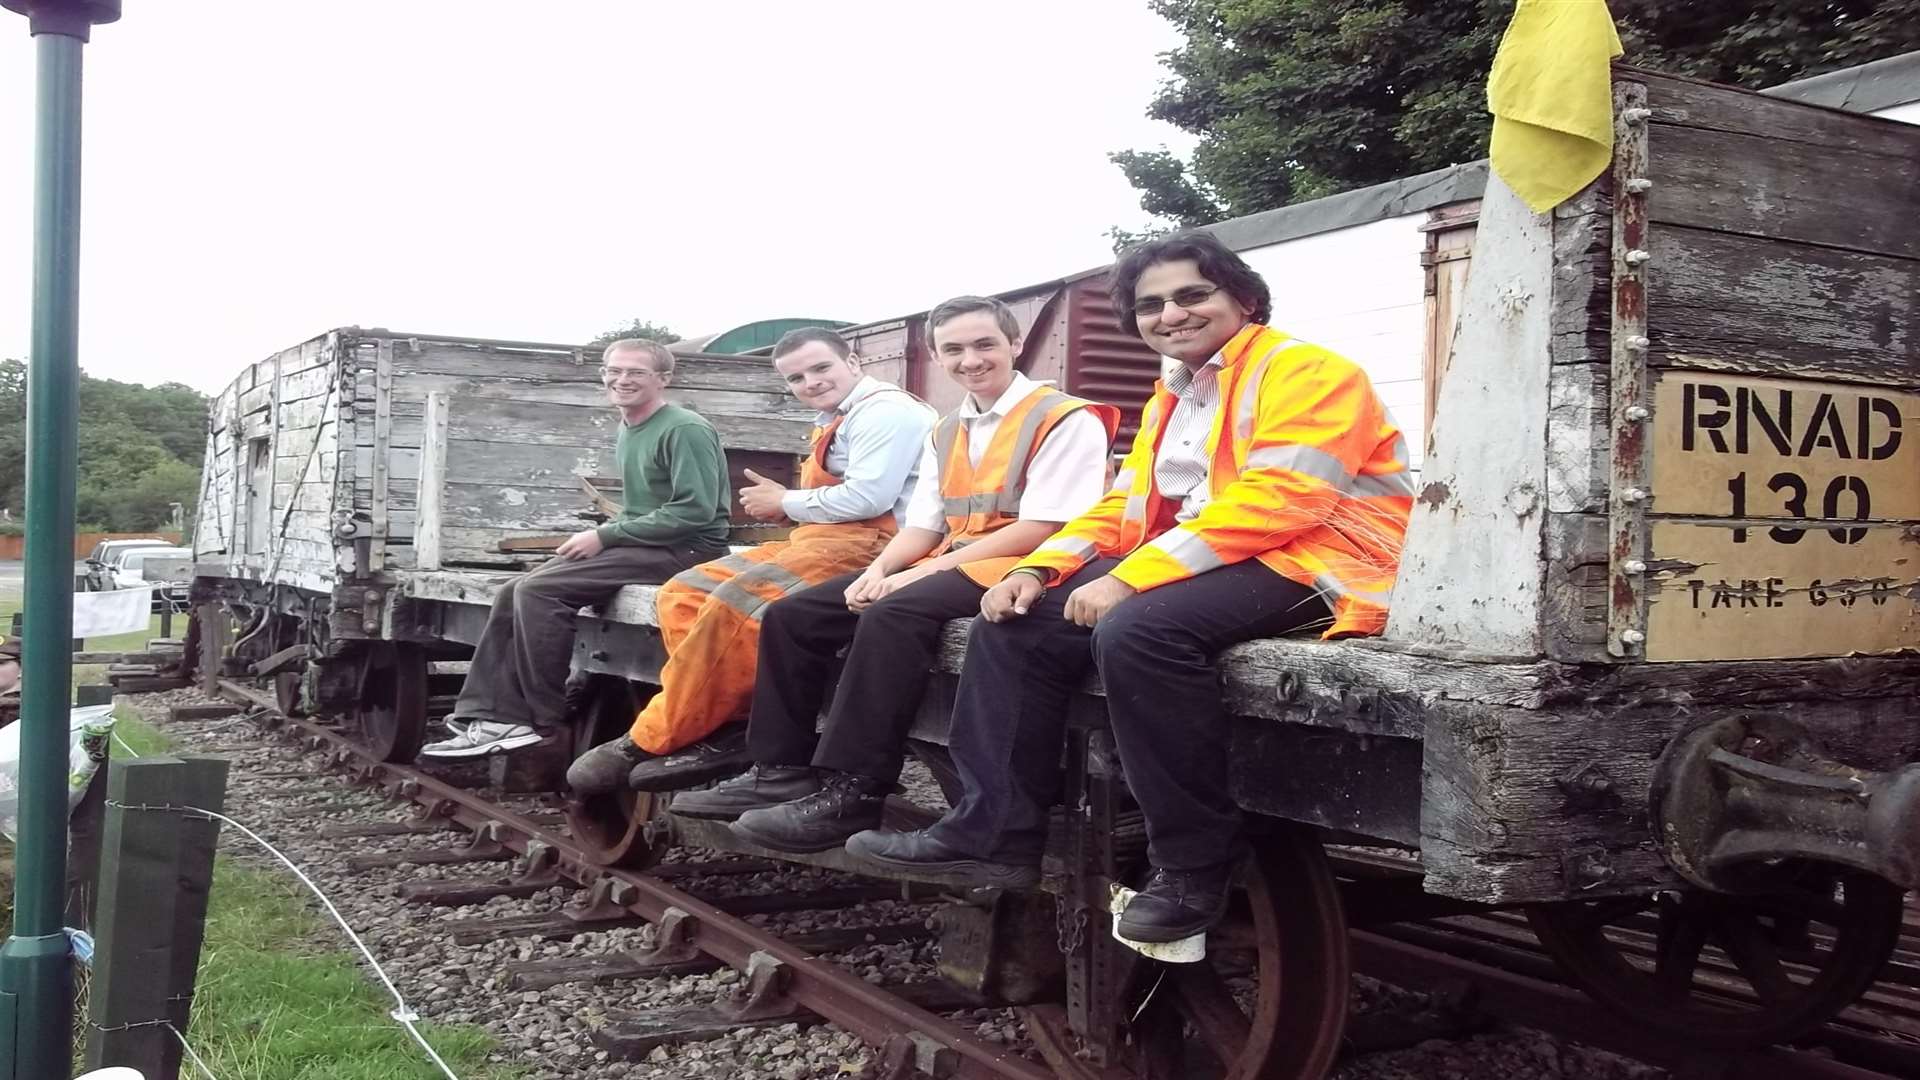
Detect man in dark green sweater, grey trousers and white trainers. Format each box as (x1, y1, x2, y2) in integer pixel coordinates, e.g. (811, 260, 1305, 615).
(420, 338, 730, 757)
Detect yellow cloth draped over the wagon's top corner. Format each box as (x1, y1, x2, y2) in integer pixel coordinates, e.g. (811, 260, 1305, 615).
(1486, 0, 1620, 213)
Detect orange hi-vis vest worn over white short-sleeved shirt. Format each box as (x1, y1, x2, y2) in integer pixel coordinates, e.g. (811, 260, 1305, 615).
(922, 384, 1119, 588)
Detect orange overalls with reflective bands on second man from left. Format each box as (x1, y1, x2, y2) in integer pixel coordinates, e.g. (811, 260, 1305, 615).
(628, 401, 899, 753)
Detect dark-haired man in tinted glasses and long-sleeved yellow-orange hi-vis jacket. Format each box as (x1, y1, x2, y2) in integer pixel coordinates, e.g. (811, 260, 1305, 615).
(847, 233, 1413, 942)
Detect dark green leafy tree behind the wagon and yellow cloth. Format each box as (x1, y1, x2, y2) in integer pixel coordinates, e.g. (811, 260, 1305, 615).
(1110, 0, 1920, 228)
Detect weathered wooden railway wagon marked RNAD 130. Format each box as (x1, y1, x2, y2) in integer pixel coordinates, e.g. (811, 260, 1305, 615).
(187, 67, 1920, 1076)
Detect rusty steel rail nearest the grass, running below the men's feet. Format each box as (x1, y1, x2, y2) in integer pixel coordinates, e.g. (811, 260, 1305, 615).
(219, 678, 1052, 1080)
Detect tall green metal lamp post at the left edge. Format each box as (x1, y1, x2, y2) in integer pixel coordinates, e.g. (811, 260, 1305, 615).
(0, 0, 119, 1080)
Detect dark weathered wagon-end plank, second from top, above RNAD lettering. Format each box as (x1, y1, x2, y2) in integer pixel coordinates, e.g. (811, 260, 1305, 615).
(1649, 123, 1920, 259)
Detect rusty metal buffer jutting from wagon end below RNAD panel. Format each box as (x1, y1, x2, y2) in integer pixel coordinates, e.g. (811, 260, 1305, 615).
(1649, 717, 1920, 892)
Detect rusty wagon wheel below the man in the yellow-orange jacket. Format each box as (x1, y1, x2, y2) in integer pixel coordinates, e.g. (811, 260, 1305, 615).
(1029, 826, 1352, 1080)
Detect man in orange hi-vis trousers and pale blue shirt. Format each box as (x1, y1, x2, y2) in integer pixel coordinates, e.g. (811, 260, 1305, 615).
(566, 327, 935, 796)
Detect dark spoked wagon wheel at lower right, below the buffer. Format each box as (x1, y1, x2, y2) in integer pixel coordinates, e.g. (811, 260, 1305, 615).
(1526, 867, 1905, 1049)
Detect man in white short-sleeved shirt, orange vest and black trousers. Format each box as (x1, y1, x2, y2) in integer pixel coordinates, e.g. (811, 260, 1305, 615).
(674, 296, 1119, 851)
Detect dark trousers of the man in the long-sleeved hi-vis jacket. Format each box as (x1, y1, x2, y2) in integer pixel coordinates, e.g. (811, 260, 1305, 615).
(933, 559, 1329, 871)
